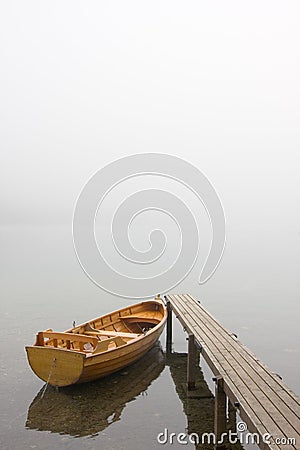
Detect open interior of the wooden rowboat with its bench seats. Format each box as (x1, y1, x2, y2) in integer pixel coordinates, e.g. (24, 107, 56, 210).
(35, 301, 165, 354)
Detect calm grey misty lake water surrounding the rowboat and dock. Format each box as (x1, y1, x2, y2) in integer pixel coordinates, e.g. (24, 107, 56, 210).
(0, 226, 300, 450)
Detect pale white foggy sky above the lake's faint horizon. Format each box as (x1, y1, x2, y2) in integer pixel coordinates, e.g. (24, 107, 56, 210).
(0, 0, 300, 229)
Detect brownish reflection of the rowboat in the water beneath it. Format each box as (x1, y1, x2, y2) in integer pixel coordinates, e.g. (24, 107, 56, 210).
(25, 344, 165, 436)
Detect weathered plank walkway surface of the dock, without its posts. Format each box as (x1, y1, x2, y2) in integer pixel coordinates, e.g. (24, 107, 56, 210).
(166, 294, 300, 450)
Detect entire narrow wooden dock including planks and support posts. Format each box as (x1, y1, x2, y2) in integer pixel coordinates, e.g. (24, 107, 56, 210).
(165, 294, 300, 450)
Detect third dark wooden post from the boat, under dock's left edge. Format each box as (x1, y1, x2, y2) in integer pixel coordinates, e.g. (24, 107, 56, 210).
(214, 375, 226, 449)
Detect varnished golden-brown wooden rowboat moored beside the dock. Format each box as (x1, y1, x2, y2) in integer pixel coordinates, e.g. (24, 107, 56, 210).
(26, 296, 167, 386)
